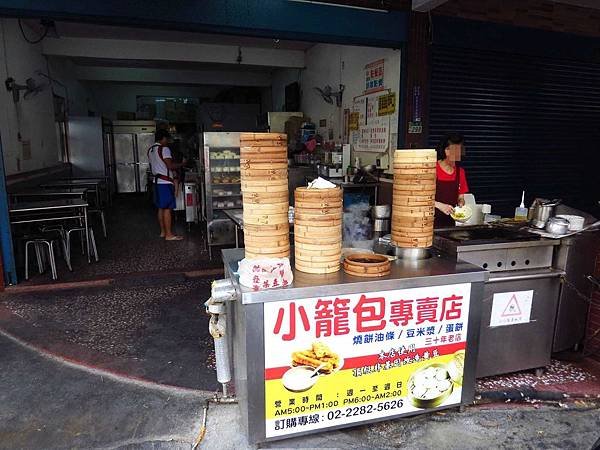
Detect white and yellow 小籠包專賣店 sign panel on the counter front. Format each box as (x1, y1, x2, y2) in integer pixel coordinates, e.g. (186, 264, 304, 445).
(263, 283, 471, 437)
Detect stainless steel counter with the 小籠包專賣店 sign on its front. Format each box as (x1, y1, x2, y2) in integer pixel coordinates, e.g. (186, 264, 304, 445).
(223, 249, 488, 443)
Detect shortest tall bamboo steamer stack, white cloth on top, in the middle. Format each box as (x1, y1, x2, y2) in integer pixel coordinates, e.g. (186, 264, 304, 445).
(294, 187, 343, 274)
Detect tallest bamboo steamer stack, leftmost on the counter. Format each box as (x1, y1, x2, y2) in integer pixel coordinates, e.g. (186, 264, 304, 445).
(240, 133, 290, 259)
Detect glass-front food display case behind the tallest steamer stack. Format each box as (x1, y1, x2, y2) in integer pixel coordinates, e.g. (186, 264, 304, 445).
(202, 132, 242, 257)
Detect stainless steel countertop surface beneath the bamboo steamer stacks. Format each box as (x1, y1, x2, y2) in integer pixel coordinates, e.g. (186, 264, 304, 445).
(223, 249, 489, 304)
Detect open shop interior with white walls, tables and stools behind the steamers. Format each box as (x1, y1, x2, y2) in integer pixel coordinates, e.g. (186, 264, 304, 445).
(2, 19, 401, 284)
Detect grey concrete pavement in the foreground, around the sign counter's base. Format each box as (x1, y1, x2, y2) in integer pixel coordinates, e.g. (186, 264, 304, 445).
(0, 336, 600, 450)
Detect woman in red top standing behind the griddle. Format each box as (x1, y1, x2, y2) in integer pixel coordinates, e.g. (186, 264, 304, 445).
(434, 133, 469, 228)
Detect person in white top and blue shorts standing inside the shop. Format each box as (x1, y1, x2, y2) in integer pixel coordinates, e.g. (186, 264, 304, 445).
(148, 129, 186, 241)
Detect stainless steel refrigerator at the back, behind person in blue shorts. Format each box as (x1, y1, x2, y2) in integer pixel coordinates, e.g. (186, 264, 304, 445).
(112, 120, 156, 193)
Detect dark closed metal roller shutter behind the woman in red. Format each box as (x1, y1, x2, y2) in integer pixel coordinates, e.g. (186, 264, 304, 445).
(429, 46, 600, 216)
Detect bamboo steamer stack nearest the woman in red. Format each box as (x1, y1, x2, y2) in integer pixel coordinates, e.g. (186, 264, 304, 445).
(391, 150, 437, 248)
